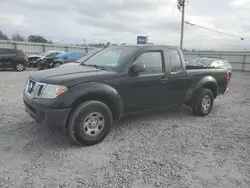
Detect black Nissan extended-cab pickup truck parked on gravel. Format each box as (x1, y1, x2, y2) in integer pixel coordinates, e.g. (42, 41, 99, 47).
(23, 45, 230, 145)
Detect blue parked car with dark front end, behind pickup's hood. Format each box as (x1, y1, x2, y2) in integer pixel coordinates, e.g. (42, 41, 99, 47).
(39, 52, 85, 69)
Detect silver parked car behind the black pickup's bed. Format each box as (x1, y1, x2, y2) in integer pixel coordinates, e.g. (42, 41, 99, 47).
(187, 57, 232, 77)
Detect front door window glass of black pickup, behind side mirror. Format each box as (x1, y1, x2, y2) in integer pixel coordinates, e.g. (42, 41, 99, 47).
(135, 52, 163, 75)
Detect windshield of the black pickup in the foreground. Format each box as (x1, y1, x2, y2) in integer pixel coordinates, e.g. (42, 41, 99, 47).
(82, 47, 137, 69)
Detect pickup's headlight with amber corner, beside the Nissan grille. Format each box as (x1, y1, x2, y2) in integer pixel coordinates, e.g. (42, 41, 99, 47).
(38, 84, 68, 99)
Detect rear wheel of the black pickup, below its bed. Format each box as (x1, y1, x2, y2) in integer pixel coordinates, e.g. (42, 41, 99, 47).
(192, 88, 214, 116)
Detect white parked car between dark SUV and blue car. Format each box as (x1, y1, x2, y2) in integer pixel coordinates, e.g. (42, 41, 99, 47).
(29, 51, 64, 67)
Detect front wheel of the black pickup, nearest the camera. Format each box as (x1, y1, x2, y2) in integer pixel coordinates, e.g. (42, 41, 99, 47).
(67, 101, 113, 145)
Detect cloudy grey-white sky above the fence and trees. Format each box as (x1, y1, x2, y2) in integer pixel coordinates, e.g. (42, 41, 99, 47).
(0, 0, 250, 50)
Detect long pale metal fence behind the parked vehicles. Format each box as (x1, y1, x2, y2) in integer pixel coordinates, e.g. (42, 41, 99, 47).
(0, 40, 250, 71)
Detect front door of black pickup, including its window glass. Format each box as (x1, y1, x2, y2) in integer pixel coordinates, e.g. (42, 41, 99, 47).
(119, 50, 168, 113)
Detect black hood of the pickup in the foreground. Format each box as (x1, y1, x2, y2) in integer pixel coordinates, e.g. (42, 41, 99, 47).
(30, 63, 117, 87)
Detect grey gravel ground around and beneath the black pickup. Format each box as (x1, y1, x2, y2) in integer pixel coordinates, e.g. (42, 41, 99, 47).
(0, 70, 250, 188)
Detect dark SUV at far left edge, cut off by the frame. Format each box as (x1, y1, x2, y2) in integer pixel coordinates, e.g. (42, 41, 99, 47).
(0, 48, 29, 71)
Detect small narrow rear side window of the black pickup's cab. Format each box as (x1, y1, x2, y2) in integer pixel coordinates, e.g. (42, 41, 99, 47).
(168, 49, 182, 72)
